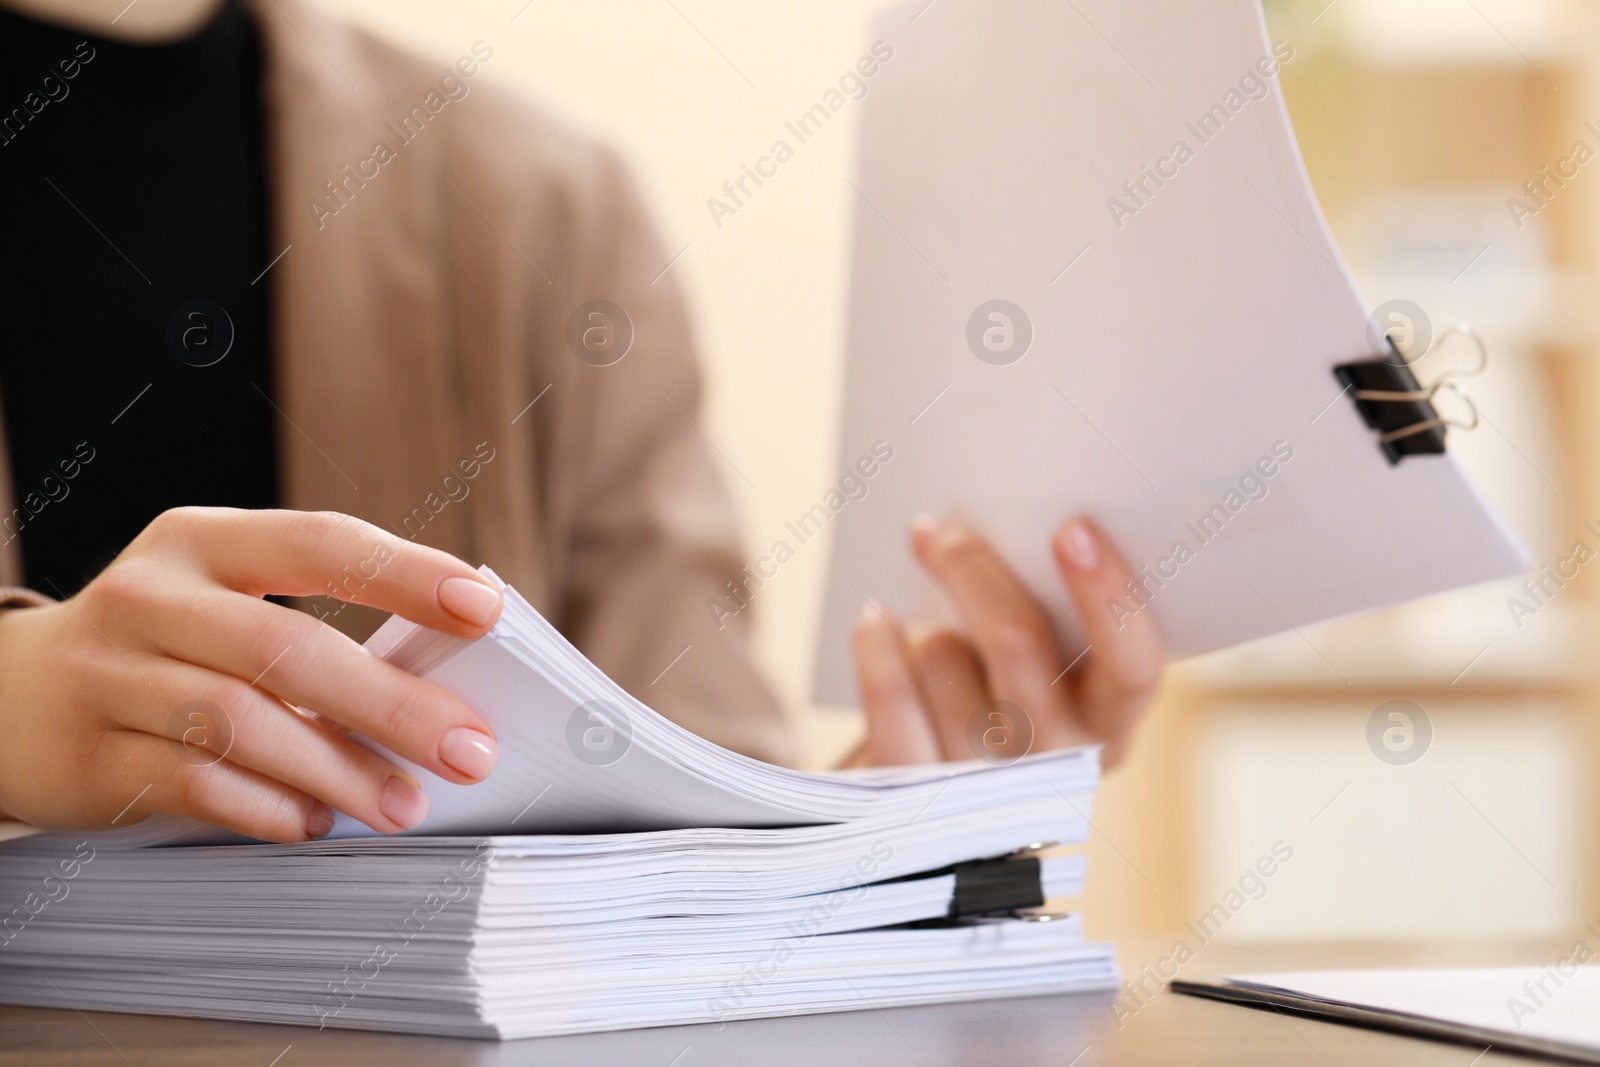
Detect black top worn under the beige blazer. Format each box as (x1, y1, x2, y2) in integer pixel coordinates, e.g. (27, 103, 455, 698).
(0, 0, 282, 595)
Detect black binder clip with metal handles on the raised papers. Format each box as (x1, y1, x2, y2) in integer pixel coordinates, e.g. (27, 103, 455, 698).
(1333, 323, 1488, 466)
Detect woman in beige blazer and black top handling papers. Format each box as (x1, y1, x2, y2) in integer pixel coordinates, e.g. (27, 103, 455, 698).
(0, 0, 1162, 841)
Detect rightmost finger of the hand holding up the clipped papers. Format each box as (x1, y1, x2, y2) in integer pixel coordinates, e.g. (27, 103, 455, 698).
(1050, 518, 1166, 765)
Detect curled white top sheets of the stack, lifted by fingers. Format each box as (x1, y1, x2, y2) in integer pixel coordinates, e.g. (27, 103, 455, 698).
(45, 568, 1099, 848)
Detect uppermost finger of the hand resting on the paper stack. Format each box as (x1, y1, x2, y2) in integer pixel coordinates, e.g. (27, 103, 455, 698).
(149, 507, 502, 637)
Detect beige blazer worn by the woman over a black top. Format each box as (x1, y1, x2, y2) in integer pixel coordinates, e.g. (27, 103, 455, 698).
(0, 0, 792, 761)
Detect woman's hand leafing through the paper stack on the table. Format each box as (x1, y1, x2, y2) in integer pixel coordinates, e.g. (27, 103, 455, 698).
(0, 507, 501, 841)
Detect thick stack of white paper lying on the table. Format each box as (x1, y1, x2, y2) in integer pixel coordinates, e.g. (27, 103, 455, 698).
(0, 572, 1118, 1038)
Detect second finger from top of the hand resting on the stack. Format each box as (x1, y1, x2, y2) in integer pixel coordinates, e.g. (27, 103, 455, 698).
(120, 577, 499, 784)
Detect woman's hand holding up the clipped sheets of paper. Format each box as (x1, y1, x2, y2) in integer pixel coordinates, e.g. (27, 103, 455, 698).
(854, 518, 1165, 766)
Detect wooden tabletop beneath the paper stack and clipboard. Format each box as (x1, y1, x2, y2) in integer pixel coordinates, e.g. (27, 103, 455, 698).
(0, 941, 1562, 1067)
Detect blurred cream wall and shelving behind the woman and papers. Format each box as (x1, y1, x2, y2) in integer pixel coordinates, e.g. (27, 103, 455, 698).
(322, 0, 1600, 947)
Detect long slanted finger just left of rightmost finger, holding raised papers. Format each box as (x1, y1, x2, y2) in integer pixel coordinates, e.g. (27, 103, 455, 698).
(912, 520, 1091, 749)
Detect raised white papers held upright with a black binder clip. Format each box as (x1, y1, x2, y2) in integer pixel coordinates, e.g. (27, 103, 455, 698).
(816, 0, 1525, 704)
